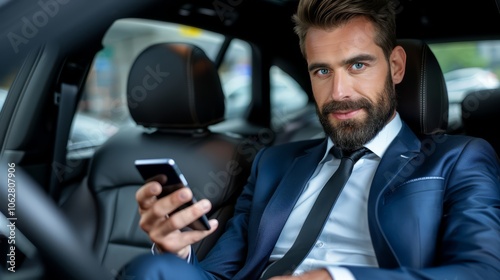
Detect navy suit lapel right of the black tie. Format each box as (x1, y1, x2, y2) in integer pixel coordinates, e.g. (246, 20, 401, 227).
(368, 123, 421, 268)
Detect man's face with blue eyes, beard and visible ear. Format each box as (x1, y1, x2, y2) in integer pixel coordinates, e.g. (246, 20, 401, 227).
(305, 17, 405, 150)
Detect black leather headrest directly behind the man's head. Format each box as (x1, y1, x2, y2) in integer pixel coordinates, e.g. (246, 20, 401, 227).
(396, 39, 448, 134)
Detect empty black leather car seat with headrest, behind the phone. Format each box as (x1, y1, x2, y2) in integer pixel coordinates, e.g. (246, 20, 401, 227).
(61, 43, 260, 271)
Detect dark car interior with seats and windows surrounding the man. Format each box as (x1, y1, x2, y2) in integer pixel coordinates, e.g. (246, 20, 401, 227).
(0, 0, 500, 279)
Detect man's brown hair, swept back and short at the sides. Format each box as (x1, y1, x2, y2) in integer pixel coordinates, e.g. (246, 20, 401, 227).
(292, 0, 396, 57)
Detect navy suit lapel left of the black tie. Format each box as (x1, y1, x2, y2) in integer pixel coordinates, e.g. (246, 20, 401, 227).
(238, 140, 327, 277)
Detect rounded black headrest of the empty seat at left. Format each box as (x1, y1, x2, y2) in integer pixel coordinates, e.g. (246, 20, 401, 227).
(127, 43, 225, 129)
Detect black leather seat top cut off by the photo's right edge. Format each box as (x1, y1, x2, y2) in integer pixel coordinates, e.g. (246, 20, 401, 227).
(461, 88, 500, 155)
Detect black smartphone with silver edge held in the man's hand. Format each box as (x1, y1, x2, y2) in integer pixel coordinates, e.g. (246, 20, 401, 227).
(134, 158, 210, 230)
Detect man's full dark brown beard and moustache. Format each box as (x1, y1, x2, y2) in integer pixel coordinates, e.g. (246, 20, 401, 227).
(316, 73, 397, 151)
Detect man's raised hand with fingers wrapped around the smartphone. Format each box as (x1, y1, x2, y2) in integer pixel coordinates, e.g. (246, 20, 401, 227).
(135, 178, 218, 258)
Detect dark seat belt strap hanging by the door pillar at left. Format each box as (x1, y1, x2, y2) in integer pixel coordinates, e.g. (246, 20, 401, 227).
(49, 83, 78, 201)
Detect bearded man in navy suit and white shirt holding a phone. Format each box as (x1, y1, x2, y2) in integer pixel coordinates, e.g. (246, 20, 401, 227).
(126, 0, 500, 280)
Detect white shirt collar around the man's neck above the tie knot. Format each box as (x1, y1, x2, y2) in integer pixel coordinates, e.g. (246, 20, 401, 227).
(322, 112, 403, 161)
